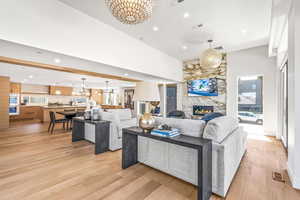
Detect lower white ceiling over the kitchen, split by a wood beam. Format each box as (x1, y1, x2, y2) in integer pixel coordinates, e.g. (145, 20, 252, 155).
(0, 40, 170, 88)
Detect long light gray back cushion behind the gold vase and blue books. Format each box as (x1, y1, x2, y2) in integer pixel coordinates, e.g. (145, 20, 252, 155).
(155, 117, 205, 137)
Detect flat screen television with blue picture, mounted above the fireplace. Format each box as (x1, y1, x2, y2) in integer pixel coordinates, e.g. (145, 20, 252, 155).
(187, 78, 218, 96)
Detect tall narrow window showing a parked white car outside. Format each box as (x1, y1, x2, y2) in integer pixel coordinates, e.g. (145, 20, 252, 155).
(238, 75, 264, 135)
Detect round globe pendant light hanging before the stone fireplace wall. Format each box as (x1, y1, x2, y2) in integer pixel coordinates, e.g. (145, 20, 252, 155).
(200, 40, 222, 68)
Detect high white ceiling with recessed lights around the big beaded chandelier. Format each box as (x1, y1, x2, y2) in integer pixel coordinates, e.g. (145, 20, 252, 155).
(60, 0, 272, 60)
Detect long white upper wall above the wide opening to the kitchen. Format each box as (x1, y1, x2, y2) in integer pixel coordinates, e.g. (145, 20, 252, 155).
(0, 0, 182, 81)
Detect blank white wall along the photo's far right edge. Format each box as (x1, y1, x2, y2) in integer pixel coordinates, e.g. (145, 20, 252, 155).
(288, 0, 300, 189)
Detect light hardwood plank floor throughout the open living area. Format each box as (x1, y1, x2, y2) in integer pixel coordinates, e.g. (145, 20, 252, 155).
(0, 121, 300, 200)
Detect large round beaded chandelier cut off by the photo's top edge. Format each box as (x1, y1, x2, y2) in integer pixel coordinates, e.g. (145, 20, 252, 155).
(105, 0, 153, 24)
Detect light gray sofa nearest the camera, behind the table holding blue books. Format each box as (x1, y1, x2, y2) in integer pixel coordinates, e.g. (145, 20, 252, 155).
(138, 117, 247, 197)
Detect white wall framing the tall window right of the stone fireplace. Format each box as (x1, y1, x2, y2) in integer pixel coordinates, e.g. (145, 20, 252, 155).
(227, 46, 277, 136)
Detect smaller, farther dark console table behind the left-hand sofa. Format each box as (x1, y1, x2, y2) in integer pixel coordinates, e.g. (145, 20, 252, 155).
(72, 117, 110, 154)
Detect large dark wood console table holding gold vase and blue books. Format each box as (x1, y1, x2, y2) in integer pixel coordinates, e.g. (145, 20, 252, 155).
(122, 127, 212, 200)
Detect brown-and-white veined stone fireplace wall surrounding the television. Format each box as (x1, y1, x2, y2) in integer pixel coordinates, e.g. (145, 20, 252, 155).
(177, 54, 227, 118)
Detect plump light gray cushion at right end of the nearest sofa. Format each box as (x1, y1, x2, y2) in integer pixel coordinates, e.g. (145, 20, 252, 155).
(203, 116, 239, 143)
